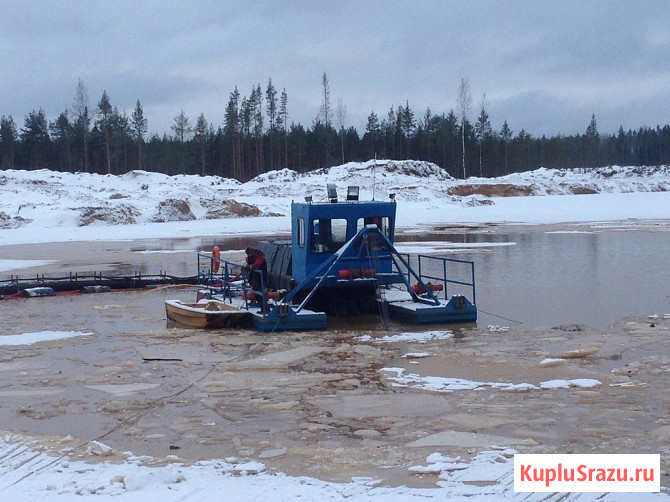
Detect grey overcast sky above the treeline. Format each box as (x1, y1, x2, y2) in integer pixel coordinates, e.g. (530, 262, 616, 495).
(0, 0, 670, 136)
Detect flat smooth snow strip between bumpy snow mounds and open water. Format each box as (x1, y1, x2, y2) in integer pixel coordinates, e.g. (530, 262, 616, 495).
(0, 192, 670, 249)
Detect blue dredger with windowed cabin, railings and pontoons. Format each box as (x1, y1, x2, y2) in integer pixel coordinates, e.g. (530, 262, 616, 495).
(184, 185, 477, 331)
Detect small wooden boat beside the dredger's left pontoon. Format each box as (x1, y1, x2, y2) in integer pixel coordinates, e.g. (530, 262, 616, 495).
(165, 300, 250, 329)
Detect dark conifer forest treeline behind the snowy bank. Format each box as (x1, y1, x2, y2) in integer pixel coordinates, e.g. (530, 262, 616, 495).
(0, 73, 670, 181)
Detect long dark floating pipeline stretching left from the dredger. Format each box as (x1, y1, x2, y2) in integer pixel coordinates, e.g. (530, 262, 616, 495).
(0, 274, 198, 299)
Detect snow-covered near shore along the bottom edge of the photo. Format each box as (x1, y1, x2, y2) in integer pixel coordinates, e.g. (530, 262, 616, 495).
(0, 435, 668, 502)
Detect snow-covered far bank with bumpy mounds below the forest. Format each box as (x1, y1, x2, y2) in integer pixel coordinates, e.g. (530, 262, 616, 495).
(0, 161, 670, 245)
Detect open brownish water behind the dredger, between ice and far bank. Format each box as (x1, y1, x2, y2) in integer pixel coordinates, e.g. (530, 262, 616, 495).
(0, 223, 670, 328)
